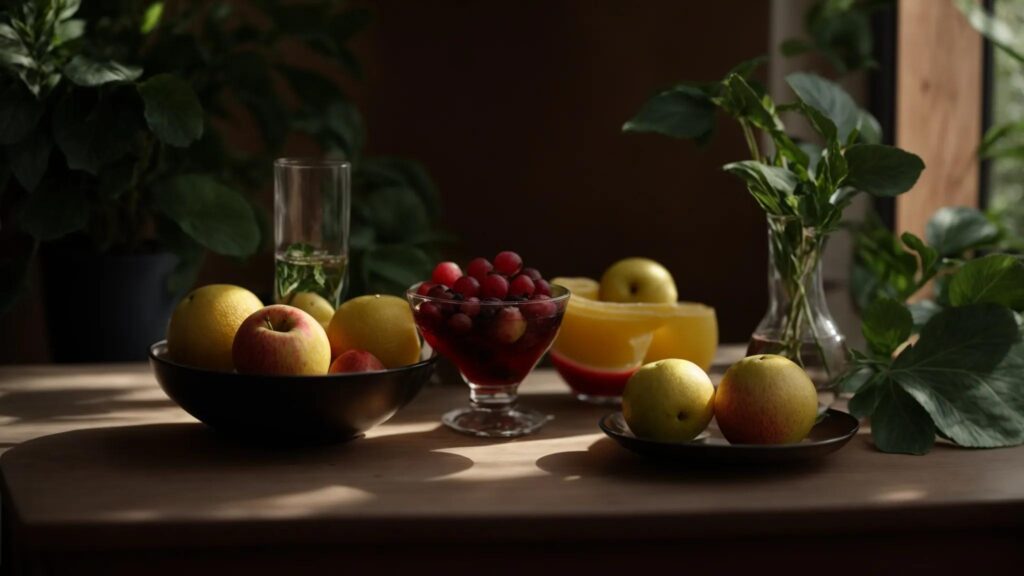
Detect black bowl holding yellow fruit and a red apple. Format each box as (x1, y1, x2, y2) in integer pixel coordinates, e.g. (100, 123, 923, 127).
(150, 340, 436, 445)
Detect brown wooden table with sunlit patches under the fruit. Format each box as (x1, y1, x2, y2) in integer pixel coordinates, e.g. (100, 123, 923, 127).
(0, 346, 1024, 576)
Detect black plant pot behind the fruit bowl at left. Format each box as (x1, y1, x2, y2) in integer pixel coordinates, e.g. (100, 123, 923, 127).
(41, 239, 178, 363)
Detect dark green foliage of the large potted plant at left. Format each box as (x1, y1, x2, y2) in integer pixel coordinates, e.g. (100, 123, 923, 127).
(0, 0, 448, 315)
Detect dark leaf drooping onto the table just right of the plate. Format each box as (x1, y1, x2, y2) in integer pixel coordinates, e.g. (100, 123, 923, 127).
(871, 381, 935, 454)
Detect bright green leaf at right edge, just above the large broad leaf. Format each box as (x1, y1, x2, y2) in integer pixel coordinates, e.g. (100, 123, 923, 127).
(948, 254, 1024, 311)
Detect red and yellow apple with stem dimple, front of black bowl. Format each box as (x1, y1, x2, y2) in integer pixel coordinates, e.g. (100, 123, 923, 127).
(231, 304, 331, 375)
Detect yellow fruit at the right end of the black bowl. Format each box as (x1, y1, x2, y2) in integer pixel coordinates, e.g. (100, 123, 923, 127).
(327, 294, 421, 368)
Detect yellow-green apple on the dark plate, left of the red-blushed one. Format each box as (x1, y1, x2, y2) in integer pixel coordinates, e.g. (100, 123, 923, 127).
(623, 359, 715, 442)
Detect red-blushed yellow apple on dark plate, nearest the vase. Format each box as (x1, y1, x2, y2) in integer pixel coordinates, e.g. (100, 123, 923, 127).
(715, 354, 818, 444)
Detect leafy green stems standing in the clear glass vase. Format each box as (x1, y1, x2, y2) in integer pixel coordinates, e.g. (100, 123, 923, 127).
(623, 60, 924, 379)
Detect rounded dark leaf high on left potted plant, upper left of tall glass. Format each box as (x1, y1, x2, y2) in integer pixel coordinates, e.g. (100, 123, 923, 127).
(138, 74, 203, 148)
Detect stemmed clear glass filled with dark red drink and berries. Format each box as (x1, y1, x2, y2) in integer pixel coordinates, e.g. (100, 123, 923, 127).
(406, 284, 569, 438)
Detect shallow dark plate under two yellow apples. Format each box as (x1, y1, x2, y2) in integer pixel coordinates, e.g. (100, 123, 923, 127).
(598, 408, 860, 464)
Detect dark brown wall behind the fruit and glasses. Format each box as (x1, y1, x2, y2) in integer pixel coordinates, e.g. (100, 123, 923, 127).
(0, 0, 769, 362)
